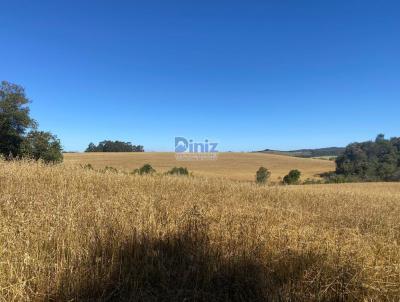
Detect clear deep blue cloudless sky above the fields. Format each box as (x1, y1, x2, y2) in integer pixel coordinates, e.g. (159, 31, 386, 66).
(0, 0, 400, 151)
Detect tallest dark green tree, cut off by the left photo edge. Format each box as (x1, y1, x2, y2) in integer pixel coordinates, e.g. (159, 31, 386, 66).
(0, 81, 36, 158)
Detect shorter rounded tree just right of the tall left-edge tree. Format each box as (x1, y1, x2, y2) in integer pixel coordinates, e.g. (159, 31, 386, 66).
(21, 130, 63, 163)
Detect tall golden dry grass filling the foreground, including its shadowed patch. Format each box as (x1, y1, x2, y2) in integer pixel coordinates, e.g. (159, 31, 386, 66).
(0, 162, 400, 301)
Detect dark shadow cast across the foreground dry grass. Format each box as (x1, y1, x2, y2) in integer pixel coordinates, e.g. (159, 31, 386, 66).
(51, 221, 362, 301)
